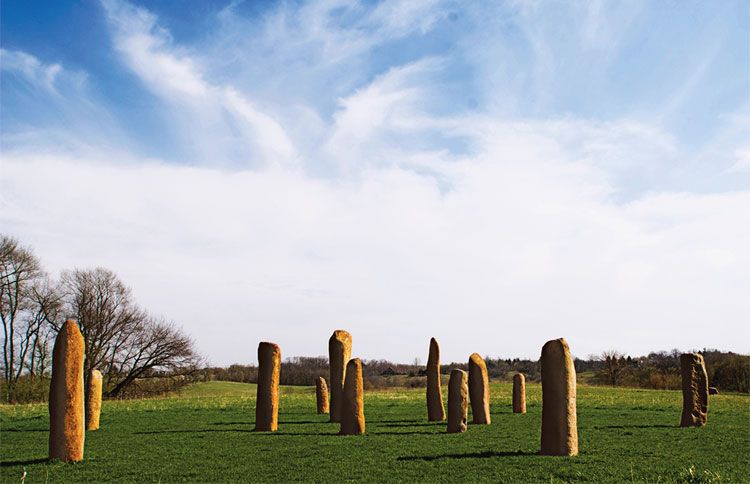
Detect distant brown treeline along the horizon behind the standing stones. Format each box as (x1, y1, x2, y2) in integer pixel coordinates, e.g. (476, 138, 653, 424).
(203, 350, 750, 393)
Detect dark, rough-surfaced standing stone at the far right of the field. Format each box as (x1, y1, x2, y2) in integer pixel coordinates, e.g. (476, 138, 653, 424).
(680, 353, 708, 427)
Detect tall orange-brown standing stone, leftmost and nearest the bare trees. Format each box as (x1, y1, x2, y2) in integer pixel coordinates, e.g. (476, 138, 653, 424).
(49, 320, 86, 462)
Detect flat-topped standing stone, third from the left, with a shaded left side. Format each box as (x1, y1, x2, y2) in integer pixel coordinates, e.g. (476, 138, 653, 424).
(255, 342, 281, 432)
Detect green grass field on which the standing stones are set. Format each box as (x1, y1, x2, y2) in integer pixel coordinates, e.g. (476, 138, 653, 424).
(0, 382, 750, 483)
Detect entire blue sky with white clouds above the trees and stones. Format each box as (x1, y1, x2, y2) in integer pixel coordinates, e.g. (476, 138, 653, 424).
(0, 0, 750, 363)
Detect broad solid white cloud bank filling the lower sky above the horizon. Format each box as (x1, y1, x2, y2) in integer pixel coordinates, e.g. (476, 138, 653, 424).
(0, 125, 750, 363)
